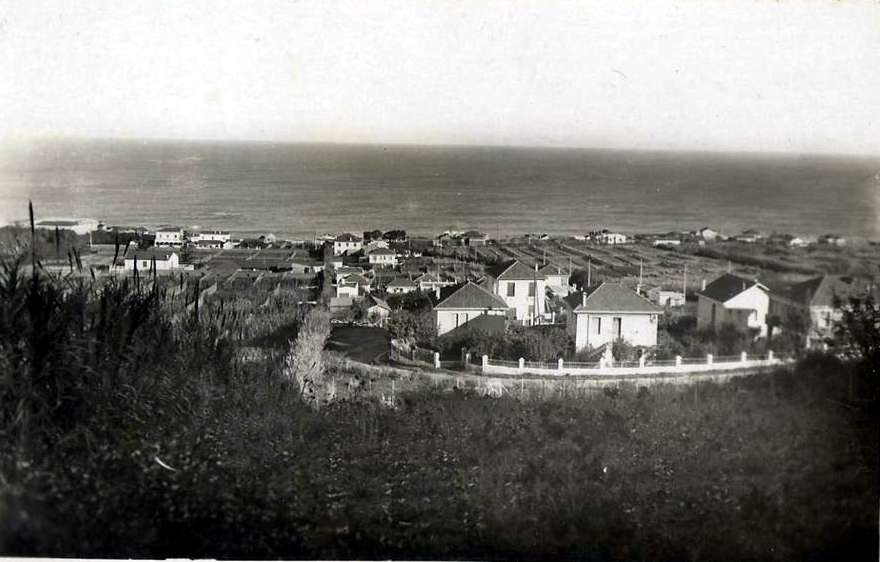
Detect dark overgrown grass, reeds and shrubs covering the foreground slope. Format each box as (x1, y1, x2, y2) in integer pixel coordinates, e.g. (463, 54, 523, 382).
(0, 248, 880, 560)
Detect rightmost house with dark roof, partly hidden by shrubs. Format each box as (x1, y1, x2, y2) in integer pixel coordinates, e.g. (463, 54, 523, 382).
(770, 275, 880, 345)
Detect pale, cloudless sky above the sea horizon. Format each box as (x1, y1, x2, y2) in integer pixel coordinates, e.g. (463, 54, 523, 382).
(0, 0, 880, 155)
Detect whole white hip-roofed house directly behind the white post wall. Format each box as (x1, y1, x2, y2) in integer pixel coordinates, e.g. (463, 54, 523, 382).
(565, 283, 663, 351)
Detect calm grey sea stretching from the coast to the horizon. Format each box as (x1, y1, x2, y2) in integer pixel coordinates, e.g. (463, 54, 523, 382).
(0, 140, 880, 239)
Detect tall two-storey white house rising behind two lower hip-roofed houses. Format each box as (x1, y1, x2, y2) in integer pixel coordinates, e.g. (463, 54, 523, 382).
(489, 260, 547, 326)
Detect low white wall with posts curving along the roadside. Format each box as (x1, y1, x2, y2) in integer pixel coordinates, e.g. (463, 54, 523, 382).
(480, 351, 788, 376)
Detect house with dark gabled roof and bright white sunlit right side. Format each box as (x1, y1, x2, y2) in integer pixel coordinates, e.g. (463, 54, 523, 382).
(697, 273, 770, 336)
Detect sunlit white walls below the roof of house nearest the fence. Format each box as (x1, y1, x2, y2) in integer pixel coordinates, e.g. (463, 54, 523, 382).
(569, 312, 657, 351)
